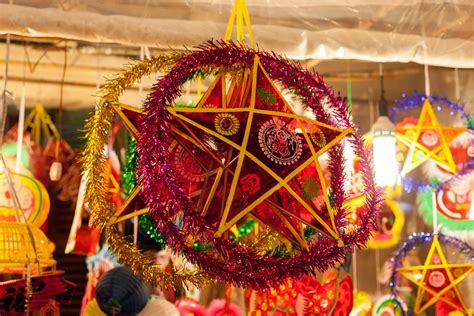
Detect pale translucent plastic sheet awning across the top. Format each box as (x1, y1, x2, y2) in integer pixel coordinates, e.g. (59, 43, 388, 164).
(0, 0, 474, 68)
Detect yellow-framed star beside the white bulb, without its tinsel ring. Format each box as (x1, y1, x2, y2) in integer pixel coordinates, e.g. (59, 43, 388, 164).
(396, 99, 466, 176)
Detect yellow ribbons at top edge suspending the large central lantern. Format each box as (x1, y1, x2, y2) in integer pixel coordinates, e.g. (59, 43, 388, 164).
(224, 0, 255, 48)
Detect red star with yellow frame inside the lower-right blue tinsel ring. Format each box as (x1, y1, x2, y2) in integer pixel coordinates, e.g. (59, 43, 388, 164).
(397, 235, 474, 314)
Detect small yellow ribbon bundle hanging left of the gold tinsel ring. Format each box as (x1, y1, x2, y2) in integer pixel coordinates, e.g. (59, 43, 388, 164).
(24, 104, 59, 144)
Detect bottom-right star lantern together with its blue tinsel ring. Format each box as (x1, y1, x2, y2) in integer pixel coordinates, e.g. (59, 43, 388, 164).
(389, 233, 474, 314)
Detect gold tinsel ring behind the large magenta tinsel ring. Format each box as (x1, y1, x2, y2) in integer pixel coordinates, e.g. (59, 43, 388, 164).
(81, 53, 277, 287)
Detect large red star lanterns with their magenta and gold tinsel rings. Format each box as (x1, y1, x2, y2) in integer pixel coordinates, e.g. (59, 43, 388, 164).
(82, 42, 380, 288)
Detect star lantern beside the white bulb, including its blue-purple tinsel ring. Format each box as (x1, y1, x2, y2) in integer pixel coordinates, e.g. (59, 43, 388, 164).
(390, 92, 474, 192)
